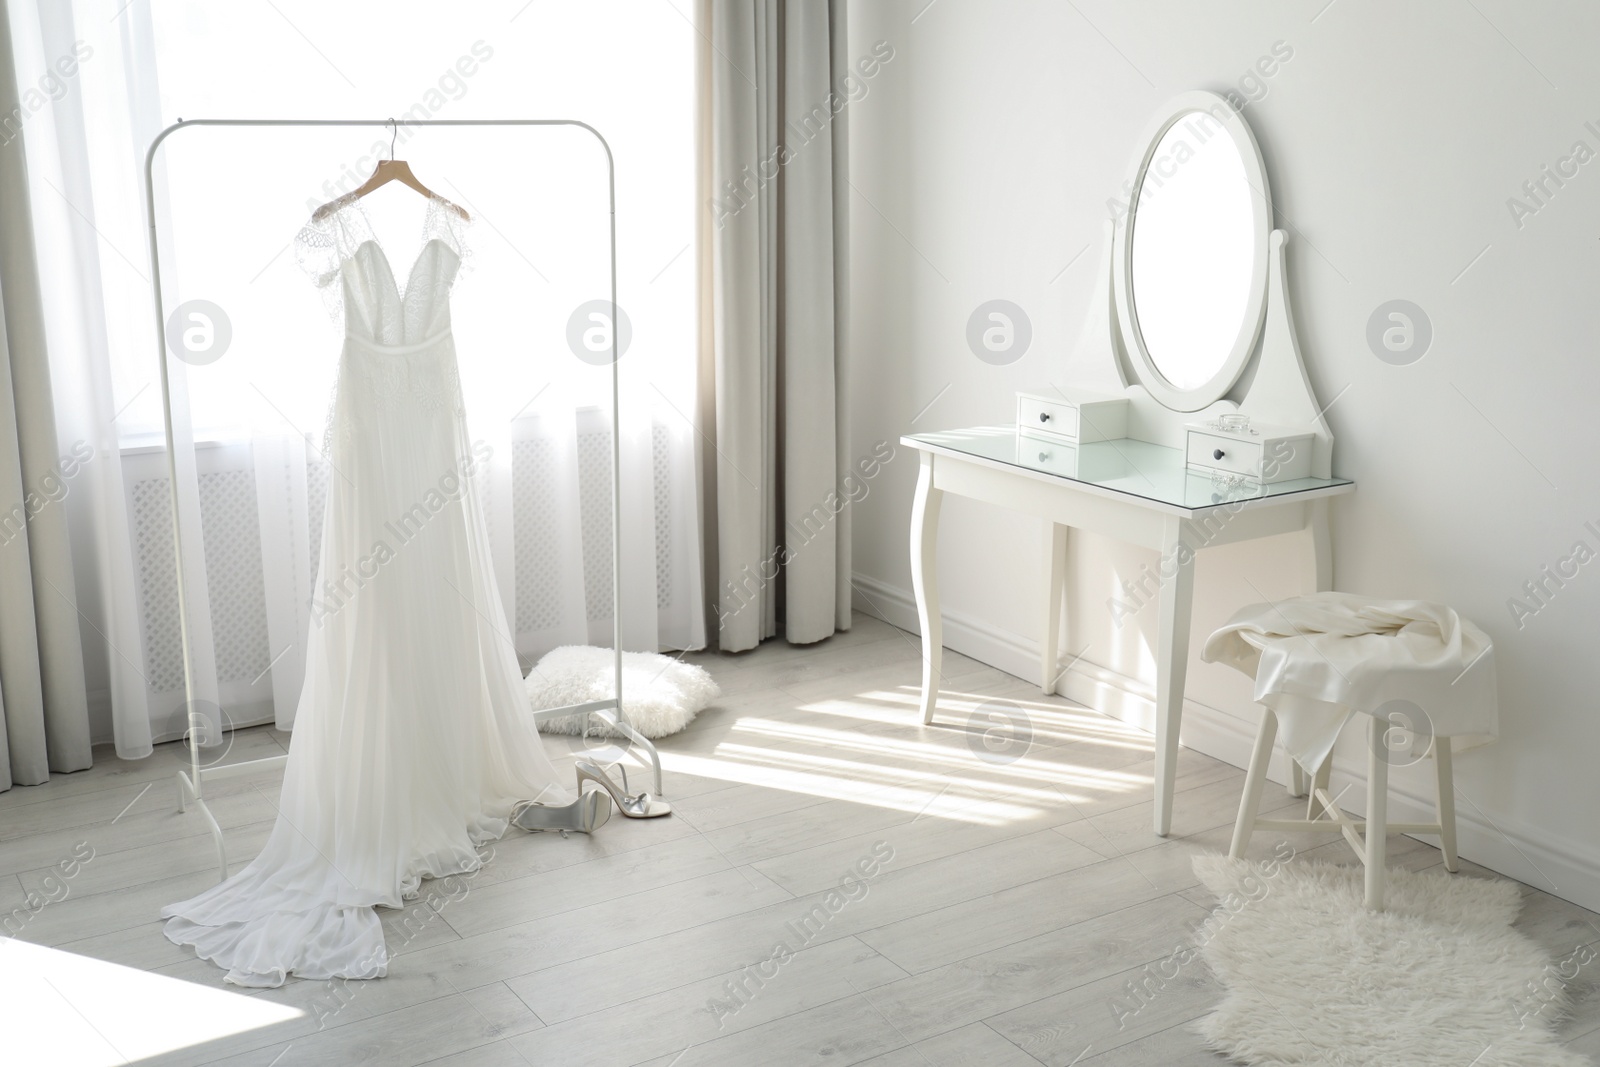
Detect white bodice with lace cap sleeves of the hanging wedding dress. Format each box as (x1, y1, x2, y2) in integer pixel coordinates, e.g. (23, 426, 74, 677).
(294, 197, 470, 346)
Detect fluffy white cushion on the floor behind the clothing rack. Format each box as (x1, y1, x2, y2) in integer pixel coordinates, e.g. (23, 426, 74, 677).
(523, 645, 722, 737)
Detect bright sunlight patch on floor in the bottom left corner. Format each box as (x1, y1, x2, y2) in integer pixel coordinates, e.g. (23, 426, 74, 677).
(0, 937, 304, 1067)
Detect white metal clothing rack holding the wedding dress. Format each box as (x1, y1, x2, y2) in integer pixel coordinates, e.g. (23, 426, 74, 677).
(144, 118, 662, 881)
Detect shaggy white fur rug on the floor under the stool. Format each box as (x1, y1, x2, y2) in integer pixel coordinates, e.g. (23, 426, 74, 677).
(1194, 856, 1589, 1067)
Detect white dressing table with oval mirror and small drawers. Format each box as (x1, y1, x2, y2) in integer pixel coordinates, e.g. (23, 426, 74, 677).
(901, 91, 1355, 837)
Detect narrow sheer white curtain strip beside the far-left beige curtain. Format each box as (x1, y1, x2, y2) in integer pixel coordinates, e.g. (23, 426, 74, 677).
(8, 0, 157, 758)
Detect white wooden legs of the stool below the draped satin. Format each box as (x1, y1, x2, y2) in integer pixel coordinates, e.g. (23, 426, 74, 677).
(1227, 707, 1459, 912)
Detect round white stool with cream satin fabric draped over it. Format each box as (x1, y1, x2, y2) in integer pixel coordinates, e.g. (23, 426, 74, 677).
(1202, 593, 1499, 910)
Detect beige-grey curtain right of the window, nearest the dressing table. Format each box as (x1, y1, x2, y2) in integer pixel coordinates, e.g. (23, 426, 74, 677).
(699, 0, 850, 651)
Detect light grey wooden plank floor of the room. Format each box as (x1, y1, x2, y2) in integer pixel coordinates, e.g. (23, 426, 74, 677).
(0, 616, 1600, 1067)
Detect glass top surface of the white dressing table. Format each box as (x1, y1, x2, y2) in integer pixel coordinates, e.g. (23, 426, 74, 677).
(904, 426, 1355, 510)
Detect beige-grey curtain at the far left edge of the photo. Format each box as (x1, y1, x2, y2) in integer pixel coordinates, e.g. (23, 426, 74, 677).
(0, 3, 91, 789)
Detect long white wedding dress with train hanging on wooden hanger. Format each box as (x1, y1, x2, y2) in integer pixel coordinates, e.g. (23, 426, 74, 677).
(162, 200, 571, 985)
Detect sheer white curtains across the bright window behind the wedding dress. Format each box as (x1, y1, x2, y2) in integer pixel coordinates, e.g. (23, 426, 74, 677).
(11, 0, 704, 757)
